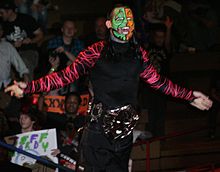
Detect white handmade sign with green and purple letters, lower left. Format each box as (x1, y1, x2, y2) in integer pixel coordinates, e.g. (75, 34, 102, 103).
(5, 129, 58, 166)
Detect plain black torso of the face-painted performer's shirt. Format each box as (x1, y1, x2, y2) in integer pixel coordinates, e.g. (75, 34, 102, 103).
(90, 42, 142, 108)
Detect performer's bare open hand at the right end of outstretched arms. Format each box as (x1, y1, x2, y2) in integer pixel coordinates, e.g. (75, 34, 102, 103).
(190, 91, 212, 110)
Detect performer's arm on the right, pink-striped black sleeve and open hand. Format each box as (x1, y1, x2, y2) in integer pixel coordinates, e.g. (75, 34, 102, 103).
(140, 49, 212, 110)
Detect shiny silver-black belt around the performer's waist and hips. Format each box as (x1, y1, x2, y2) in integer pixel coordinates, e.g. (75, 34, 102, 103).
(90, 103, 139, 140)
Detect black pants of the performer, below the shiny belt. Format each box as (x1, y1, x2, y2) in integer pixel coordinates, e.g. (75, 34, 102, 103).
(80, 122, 133, 172)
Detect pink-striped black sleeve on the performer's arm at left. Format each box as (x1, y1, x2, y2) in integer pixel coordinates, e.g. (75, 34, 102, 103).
(24, 42, 104, 94)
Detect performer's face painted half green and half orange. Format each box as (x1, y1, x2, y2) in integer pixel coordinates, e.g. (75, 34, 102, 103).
(111, 7, 134, 41)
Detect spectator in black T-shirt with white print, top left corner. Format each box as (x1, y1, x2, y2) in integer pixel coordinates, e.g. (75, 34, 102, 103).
(0, 0, 43, 79)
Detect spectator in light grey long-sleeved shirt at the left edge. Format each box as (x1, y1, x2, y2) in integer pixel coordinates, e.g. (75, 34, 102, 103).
(0, 20, 29, 133)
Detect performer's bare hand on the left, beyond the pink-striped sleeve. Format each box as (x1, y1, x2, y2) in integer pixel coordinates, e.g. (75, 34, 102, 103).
(5, 81, 27, 98)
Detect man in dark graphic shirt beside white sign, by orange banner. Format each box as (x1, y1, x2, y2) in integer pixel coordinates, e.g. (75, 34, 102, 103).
(39, 92, 87, 170)
